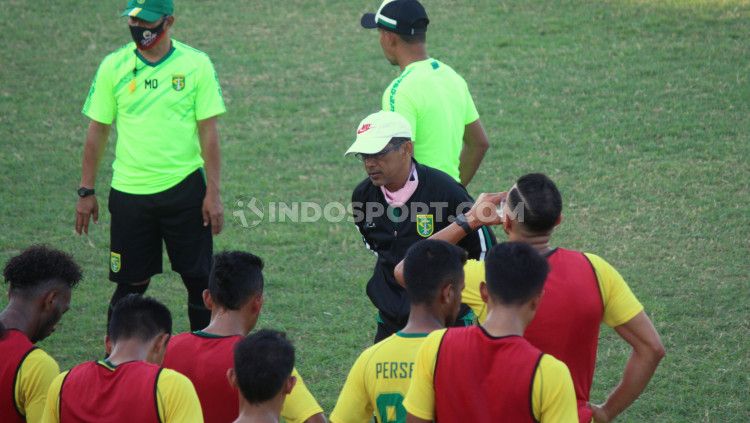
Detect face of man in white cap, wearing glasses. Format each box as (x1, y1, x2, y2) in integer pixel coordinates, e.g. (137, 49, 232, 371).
(363, 142, 414, 191)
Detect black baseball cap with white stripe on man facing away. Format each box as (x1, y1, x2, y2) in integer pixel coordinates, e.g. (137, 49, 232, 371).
(360, 0, 430, 35)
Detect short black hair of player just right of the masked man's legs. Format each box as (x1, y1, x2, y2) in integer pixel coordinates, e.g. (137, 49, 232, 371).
(208, 251, 263, 310)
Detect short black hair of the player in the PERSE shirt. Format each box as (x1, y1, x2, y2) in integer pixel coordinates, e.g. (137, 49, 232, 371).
(404, 239, 467, 304)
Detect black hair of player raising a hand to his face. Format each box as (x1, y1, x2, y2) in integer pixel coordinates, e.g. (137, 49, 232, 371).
(508, 173, 562, 233)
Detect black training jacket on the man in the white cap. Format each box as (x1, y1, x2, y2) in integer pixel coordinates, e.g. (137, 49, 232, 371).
(352, 162, 495, 325)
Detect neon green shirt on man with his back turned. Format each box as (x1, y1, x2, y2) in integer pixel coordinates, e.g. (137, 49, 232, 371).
(383, 59, 479, 181)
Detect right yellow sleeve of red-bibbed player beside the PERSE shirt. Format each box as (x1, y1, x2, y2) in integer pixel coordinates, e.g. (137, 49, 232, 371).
(531, 354, 578, 423)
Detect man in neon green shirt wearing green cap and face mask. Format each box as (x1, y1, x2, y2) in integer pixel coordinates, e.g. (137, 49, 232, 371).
(76, 0, 226, 330)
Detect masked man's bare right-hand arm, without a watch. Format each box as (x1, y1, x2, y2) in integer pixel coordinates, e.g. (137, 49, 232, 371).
(198, 116, 224, 235)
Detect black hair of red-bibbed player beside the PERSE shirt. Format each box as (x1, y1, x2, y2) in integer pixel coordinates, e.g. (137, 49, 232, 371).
(484, 242, 549, 305)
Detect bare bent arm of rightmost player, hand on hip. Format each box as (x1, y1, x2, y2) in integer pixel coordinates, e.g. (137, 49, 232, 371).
(591, 311, 665, 422)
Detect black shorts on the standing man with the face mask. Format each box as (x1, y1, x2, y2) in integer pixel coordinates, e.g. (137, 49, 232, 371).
(109, 169, 213, 283)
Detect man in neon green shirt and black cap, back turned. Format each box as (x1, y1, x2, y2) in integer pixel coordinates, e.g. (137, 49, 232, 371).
(360, 0, 490, 186)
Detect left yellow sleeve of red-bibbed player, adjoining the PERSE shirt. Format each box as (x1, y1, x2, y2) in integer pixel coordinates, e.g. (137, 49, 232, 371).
(403, 329, 446, 420)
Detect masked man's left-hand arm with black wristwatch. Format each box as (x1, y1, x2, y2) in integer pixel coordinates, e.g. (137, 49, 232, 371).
(76, 120, 110, 235)
